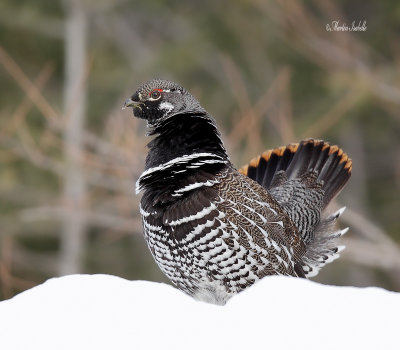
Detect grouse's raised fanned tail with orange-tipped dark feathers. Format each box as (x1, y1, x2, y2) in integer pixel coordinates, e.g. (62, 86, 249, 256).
(239, 139, 352, 277)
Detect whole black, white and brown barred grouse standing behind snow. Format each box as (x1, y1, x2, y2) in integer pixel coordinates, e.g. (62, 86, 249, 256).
(123, 79, 352, 305)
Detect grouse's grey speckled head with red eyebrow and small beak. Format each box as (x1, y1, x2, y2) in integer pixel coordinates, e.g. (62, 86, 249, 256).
(123, 79, 206, 128)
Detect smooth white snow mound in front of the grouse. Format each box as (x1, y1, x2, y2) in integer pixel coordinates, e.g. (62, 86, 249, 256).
(0, 275, 400, 350)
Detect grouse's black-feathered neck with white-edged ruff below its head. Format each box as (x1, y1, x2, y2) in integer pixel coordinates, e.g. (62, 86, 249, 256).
(136, 115, 230, 198)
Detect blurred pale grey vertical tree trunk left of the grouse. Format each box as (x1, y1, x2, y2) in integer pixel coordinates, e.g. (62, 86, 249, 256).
(59, 0, 87, 275)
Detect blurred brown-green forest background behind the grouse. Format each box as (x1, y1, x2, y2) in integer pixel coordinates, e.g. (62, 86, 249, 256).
(0, 0, 400, 300)
